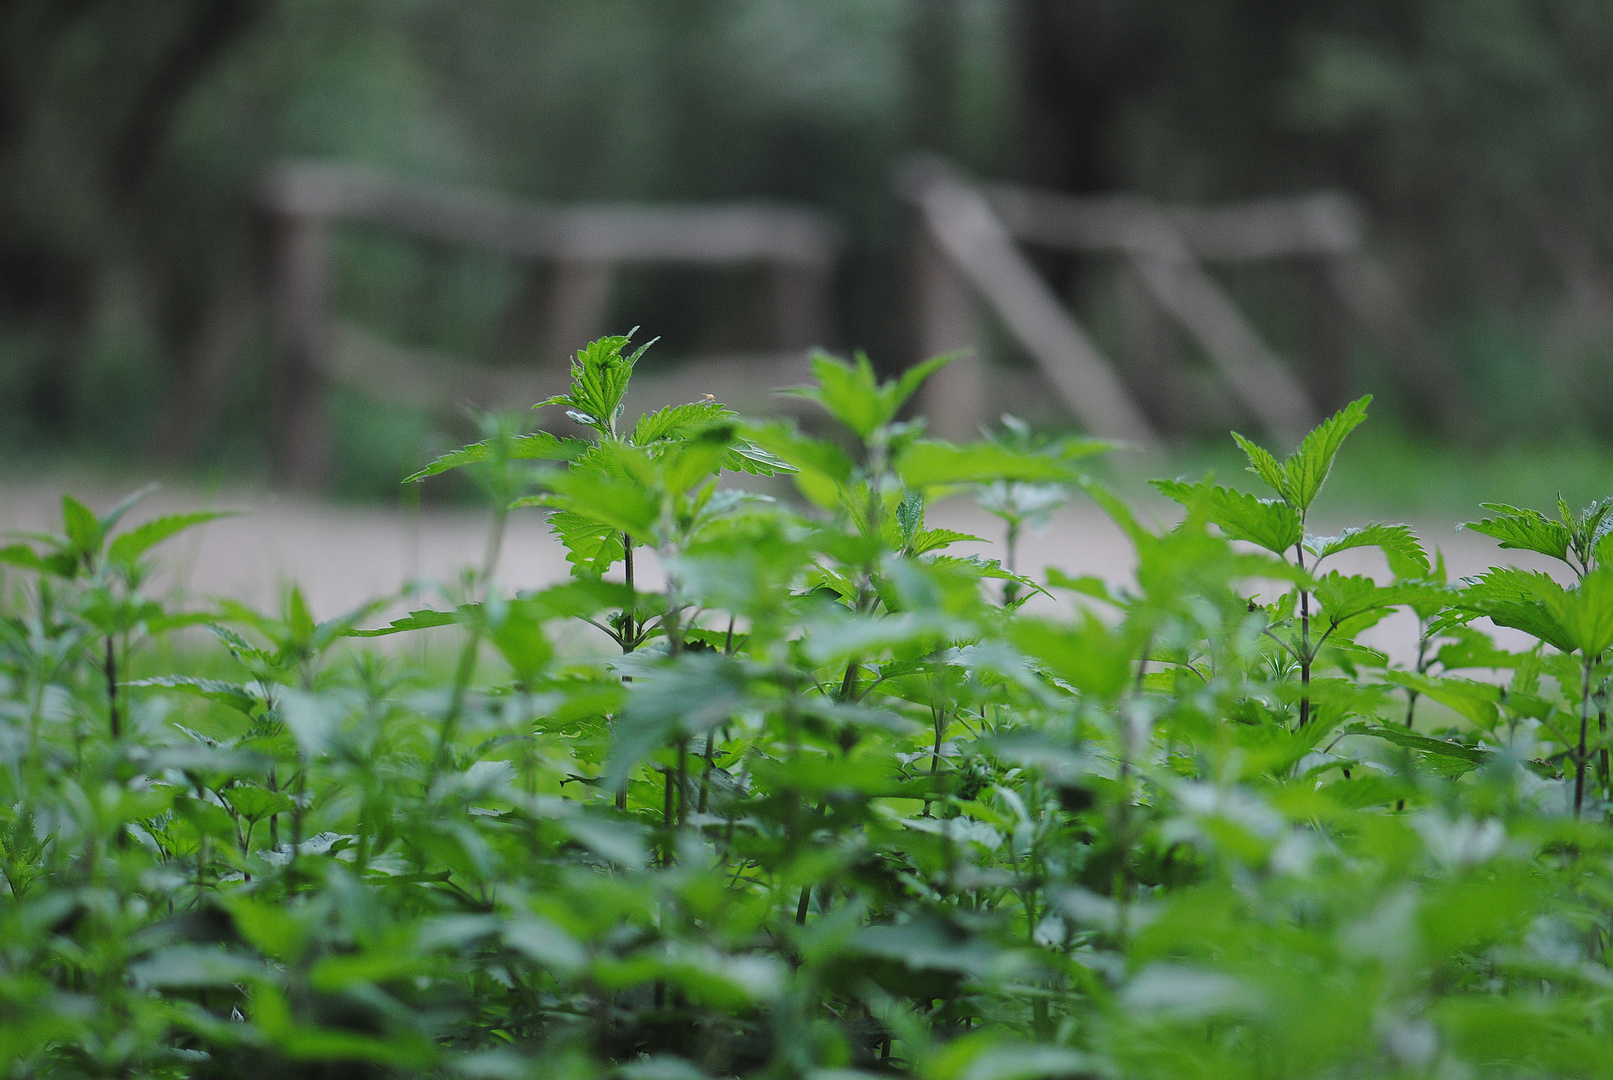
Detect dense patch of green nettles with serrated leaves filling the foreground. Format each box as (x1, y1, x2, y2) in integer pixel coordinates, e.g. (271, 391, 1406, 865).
(0, 337, 1613, 1080)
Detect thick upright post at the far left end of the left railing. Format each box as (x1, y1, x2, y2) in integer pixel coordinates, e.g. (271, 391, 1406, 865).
(271, 213, 331, 490)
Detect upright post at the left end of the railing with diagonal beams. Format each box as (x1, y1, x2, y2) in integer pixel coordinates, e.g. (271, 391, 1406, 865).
(915, 226, 990, 442)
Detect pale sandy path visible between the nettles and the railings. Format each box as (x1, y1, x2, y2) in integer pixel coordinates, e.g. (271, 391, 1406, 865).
(0, 477, 1555, 659)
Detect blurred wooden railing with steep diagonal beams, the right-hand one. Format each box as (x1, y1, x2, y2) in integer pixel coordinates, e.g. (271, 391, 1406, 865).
(898, 158, 1465, 445)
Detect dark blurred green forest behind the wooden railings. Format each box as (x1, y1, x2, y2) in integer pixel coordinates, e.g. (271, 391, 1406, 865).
(0, 0, 1613, 498)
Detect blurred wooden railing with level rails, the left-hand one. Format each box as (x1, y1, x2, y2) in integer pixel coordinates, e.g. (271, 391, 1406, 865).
(160, 164, 840, 488)
